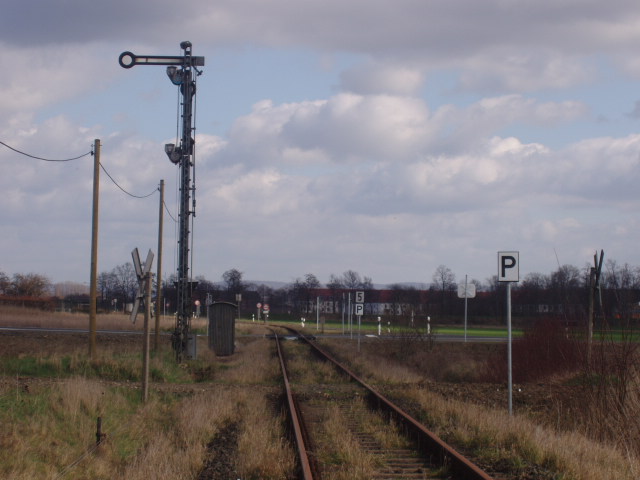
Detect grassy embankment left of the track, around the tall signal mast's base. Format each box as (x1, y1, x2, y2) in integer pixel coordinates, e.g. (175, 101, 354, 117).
(0, 311, 294, 480)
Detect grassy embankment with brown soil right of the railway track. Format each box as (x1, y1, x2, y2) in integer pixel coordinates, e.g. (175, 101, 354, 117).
(322, 332, 640, 480)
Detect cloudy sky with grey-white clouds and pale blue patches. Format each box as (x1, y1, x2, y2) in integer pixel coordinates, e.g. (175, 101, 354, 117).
(0, 0, 640, 284)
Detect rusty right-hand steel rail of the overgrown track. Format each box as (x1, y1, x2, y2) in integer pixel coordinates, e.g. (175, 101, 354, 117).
(282, 326, 494, 480)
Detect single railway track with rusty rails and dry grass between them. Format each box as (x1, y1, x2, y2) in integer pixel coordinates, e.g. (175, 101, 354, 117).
(274, 327, 492, 480)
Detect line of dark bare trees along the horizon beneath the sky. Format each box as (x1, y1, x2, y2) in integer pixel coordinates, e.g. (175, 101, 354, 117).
(5, 259, 640, 323)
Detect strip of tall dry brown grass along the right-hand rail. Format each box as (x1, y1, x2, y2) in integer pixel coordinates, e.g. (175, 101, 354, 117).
(318, 342, 640, 480)
